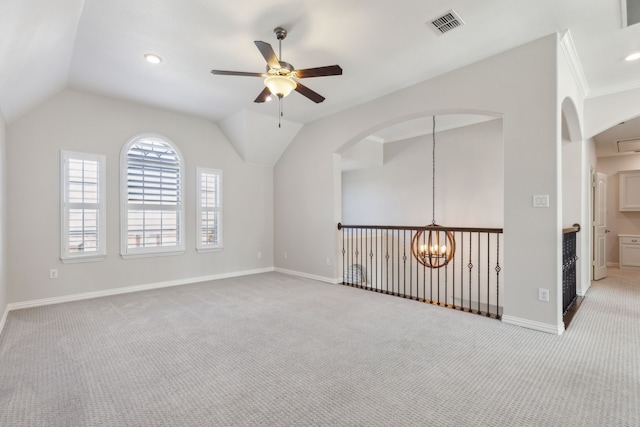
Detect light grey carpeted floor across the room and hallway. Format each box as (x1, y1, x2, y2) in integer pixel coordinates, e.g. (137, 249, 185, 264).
(0, 270, 640, 426)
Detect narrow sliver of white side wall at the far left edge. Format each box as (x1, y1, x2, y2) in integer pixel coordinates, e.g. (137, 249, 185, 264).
(0, 111, 8, 332)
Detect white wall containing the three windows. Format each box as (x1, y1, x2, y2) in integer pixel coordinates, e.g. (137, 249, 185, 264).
(7, 90, 273, 303)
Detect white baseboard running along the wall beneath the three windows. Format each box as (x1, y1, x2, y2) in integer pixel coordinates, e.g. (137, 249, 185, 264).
(5, 267, 274, 314)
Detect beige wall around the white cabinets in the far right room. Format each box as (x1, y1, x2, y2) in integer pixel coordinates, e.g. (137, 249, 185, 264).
(597, 154, 640, 265)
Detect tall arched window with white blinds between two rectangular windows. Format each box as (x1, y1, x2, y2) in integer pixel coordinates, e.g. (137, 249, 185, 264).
(120, 135, 184, 258)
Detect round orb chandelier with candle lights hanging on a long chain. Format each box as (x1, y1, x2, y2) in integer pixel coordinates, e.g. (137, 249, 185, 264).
(411, 116, 456, 268)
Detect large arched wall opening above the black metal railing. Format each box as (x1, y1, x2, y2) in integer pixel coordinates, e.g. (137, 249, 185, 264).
(336, 110, 504, 228)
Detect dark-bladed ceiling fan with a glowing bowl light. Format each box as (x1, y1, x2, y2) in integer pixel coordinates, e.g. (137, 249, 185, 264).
(211, 27, 342, 107)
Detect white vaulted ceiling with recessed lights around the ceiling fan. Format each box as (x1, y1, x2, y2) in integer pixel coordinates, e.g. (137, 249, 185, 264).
(0, 0, 640, 153)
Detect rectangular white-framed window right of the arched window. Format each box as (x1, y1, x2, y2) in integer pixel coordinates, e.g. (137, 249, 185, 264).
(196, 168, 222, 252)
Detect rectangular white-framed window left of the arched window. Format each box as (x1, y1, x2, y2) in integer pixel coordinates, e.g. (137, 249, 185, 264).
(60, 151, 106, 262)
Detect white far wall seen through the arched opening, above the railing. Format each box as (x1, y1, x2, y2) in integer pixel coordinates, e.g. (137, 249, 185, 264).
(342, 118, 504, 228)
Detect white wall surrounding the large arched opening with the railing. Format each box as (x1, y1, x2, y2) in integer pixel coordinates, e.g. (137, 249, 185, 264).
(274, 34, 562, 332)
